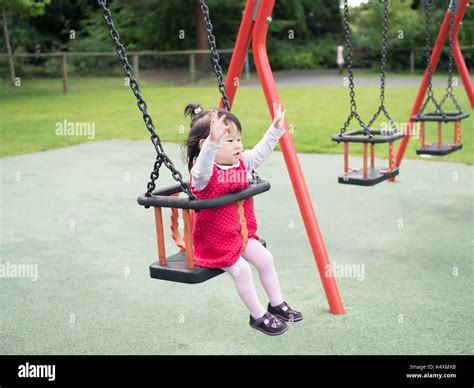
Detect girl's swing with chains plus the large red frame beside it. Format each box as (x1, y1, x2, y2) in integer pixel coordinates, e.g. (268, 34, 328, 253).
(98, 0, 344, 314)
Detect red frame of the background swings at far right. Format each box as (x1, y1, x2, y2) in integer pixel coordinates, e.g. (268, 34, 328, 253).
(389, 0, 474, 182)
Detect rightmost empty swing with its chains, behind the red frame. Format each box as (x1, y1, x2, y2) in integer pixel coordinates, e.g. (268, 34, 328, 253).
(412, 0, 469, 156)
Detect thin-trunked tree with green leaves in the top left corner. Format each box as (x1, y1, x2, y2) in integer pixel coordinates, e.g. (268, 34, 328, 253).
(0, 0, 50, 85)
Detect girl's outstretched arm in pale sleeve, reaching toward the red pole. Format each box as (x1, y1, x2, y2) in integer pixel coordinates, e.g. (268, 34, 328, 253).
(242, 103, 286, 170)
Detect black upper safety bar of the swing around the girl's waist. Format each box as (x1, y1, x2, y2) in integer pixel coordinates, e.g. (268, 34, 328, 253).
(137, 180, 270, 211)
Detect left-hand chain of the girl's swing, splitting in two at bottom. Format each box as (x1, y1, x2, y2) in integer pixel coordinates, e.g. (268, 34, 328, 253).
(98, 0, 196, 200)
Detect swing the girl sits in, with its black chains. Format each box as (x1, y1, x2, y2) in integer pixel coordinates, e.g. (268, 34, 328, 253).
(99, 0, 270, 284)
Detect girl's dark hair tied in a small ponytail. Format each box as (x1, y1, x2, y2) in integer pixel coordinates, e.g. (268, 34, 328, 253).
(183, 103, 242, 171)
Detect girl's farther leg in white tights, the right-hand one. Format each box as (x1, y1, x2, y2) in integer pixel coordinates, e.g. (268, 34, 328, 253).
(242, 238, 283, 306)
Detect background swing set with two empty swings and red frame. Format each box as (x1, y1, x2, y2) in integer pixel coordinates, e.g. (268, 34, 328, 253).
(332, 0, 474, 186)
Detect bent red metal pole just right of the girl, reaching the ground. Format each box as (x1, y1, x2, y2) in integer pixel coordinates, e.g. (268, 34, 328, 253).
(252, 0, 345, 314)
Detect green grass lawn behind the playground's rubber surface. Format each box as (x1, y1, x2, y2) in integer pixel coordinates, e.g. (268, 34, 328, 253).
(0, 78, 474, 164)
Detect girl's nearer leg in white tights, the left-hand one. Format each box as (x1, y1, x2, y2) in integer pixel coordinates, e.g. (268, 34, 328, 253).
(223, 257, 266, 319)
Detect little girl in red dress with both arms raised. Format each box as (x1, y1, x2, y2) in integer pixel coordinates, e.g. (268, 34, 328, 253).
(185, 104, 303, 335)
